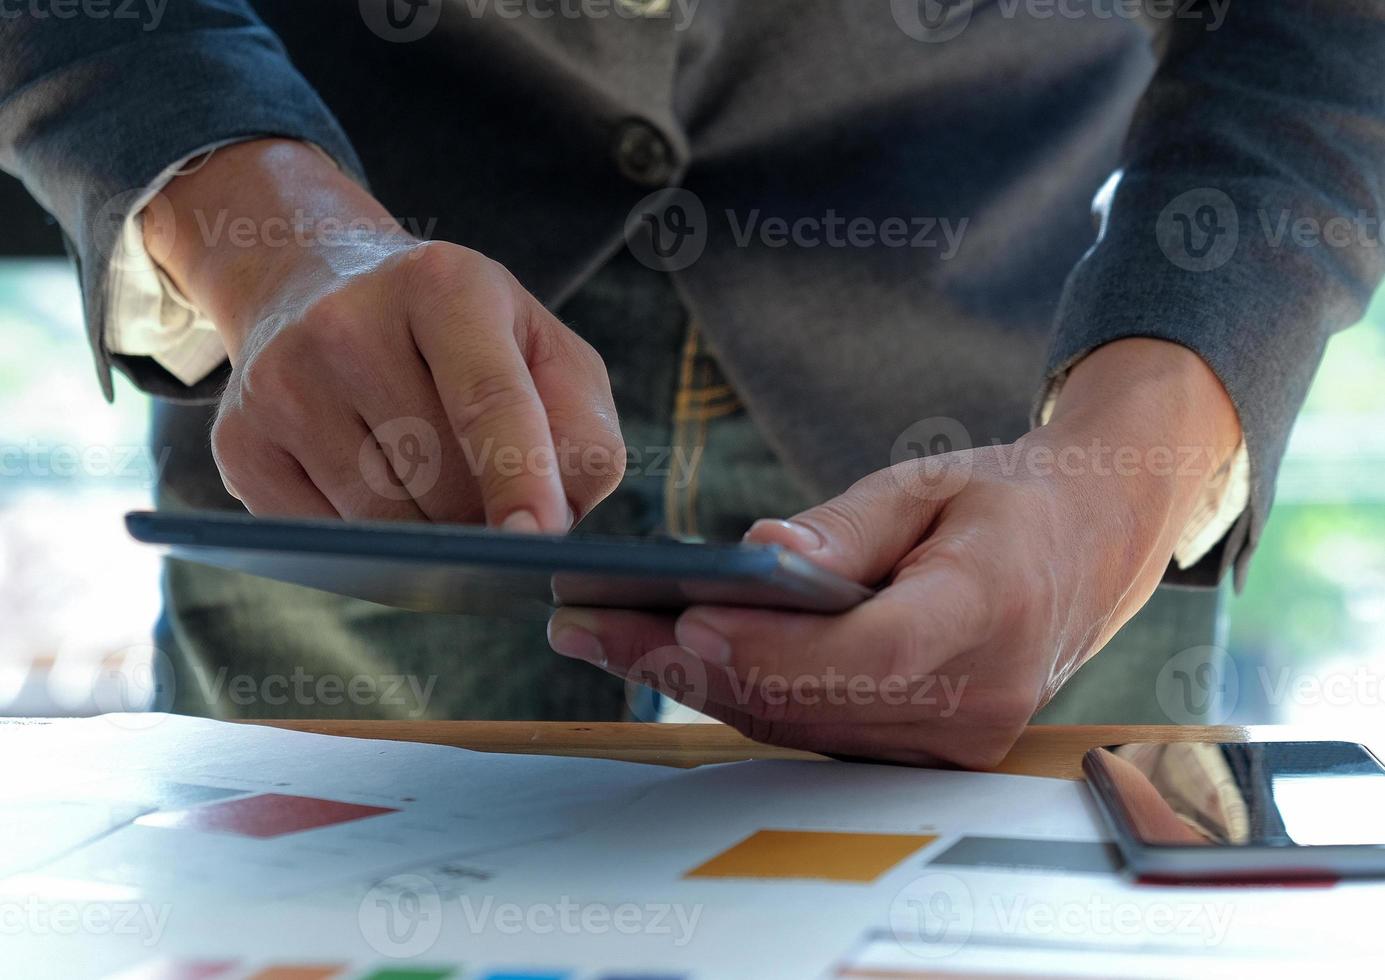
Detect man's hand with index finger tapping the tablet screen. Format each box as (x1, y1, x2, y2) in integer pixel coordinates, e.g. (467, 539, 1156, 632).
(145, 141, 625, 533)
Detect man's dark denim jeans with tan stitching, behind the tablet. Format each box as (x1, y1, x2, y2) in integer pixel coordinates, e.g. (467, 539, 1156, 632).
(152, 252, 1217, 723)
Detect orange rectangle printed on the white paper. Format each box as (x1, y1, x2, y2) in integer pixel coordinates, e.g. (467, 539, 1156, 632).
(686, 831, 938, 883)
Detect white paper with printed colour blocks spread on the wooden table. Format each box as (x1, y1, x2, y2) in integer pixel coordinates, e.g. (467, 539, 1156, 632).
(0, 717, 1385, 980)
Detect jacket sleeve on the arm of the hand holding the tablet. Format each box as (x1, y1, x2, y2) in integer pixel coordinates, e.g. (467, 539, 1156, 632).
(1040, 0, 1385, 586)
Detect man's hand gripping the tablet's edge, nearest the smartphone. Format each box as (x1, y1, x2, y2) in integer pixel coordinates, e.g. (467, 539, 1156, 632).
(550, 341, 1240, 767)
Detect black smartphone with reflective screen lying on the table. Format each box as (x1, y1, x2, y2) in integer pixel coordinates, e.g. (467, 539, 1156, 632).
(1083, 742, 1385, 883)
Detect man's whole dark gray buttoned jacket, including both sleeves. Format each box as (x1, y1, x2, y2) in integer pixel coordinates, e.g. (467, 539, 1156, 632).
(0, 0, 1385, 584)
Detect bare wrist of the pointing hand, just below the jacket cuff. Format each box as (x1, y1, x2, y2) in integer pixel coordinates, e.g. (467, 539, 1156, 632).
(144, 140, 403, 360)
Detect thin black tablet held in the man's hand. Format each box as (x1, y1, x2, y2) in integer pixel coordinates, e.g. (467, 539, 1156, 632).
(125, 512, 871, 619)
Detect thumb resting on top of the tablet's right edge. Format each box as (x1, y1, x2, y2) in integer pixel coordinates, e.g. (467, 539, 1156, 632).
(745, 454, 970, 586)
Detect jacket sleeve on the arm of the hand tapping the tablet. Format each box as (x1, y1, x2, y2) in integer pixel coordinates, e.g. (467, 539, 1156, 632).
(0, 0, 360, 400)
